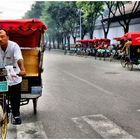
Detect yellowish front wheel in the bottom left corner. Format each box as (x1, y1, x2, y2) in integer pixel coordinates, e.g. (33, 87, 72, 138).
(0, 114, 8, 139)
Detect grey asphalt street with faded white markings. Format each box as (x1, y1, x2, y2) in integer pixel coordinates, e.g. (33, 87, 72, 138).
(8, 50, 140, 139)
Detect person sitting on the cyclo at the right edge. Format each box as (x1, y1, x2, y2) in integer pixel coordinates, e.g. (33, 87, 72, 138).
(121, 38, 132, 62)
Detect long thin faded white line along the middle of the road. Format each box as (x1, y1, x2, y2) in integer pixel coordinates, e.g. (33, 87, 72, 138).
(63, 71, 113, 95)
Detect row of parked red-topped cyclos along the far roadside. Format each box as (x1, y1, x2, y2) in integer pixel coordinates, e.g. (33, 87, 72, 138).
(66, 32, 140, 70)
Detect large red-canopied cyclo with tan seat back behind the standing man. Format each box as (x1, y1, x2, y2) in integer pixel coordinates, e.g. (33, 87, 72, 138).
(0, 19, 47, 138)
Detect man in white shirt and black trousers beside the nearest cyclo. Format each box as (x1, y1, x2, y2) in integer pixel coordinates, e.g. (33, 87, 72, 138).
(0, 29, 26, 125)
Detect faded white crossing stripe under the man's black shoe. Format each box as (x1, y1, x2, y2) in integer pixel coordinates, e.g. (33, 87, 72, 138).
(7, 121, 48, 139)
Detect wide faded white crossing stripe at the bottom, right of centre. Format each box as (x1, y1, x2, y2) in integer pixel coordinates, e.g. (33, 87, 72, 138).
(72, 114, 134, 139)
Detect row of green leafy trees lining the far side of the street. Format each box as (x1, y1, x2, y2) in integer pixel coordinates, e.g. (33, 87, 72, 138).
(23, 1, 140, 47)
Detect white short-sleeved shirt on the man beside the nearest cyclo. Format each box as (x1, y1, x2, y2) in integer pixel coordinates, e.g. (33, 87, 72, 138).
(0, 40, 23, 86)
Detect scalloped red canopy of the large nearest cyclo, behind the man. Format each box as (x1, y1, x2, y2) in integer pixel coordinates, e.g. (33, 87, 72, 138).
(0, 19, 47, 47)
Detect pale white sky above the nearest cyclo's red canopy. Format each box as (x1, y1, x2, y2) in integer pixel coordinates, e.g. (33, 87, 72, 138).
(0, 0, 35, 19)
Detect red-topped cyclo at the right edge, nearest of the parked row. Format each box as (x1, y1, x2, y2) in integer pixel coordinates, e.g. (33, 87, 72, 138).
(121, 32, 140, 71)
